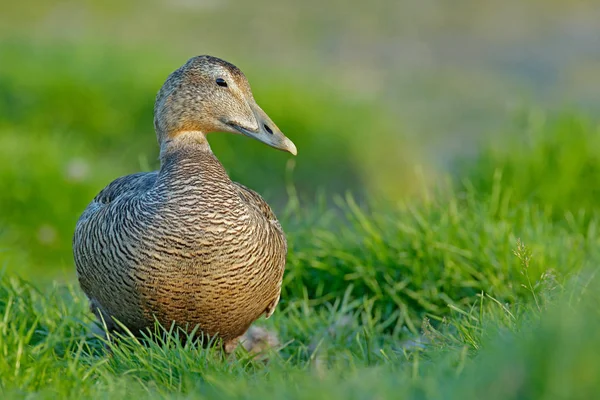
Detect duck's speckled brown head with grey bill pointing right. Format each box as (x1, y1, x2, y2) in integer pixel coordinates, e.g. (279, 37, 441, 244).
(154, 56, 296, 155)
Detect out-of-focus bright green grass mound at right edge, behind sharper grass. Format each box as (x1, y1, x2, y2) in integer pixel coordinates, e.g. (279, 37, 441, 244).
(458, 110, 600, 220)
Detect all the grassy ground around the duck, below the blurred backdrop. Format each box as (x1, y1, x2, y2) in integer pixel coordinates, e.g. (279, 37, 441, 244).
(0, 184, 600, 399)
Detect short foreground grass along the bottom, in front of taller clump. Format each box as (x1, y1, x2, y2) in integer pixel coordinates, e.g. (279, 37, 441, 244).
(0, 222, 600, 399)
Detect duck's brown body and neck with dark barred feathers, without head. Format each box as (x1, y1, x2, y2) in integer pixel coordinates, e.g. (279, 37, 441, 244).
(73, 142, 287, 343)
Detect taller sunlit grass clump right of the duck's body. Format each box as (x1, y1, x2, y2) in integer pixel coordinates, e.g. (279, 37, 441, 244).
(284, 185, 600, 333)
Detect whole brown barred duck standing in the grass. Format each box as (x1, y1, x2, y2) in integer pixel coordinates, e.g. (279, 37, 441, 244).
(73, 55, 297, 353)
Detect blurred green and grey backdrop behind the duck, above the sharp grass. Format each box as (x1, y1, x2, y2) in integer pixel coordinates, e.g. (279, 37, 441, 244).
(0, 0, 600, 282)
